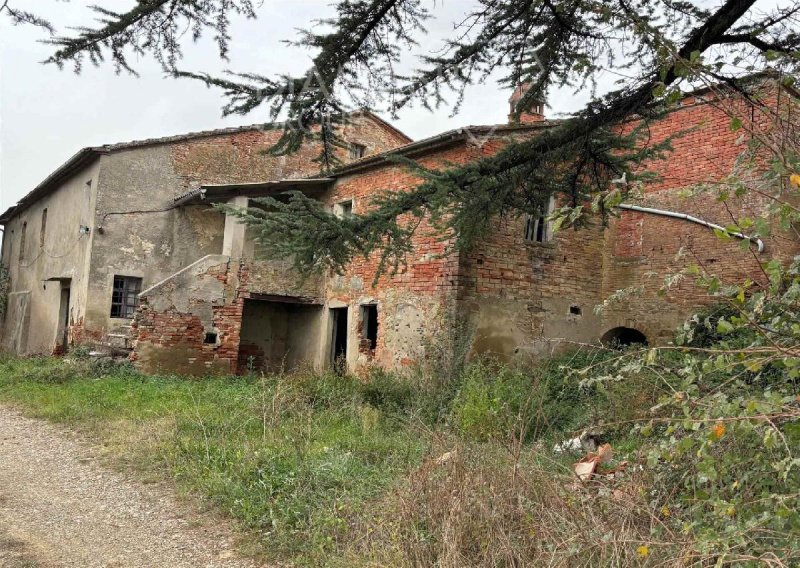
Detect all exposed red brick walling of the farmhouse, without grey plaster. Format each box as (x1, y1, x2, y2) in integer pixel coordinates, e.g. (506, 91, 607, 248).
(128, 81, 800, 378)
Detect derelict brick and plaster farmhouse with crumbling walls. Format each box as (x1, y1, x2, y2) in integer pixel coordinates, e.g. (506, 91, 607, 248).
(0, 81, 800, 374)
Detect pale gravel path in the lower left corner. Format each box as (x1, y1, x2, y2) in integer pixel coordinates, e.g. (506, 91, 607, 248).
(0, 406, 262, 568)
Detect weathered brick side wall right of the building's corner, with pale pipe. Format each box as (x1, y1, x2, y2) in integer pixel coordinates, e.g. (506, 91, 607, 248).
(460, 83, 800, 358)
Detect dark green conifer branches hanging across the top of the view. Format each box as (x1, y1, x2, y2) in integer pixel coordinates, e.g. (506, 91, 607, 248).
(9, 0, 800, 271)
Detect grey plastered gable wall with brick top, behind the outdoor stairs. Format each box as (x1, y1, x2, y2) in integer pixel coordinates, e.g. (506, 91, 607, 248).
(85, 115, 406, 348)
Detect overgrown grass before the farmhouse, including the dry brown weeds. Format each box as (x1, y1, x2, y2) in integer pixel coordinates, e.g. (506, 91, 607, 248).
(0, 351, 675, 567)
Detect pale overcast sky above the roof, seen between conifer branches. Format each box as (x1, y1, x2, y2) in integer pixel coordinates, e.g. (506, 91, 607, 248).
(0, 0, 608, 210)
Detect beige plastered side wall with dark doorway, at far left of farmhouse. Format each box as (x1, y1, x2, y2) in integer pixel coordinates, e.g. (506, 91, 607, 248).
(1, 162, 99, 354)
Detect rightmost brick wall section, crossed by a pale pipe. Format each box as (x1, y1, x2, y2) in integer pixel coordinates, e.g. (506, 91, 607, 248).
(602, 90, 800, 343)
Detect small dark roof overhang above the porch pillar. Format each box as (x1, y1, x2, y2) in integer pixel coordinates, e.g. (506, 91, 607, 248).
(173, 178, 334, 207)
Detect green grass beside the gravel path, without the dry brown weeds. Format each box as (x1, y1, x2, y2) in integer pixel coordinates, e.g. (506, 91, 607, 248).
(0, 356, 624, 566)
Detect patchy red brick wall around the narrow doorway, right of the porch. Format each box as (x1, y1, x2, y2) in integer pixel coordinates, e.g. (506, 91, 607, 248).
(325, 143, 476, 367)
